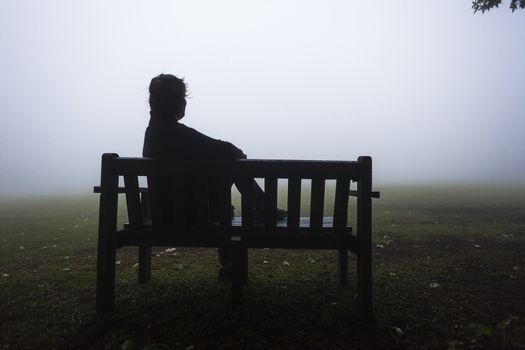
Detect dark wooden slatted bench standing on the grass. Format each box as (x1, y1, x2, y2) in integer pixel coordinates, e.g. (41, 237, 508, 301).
(95, 153, 379, 318)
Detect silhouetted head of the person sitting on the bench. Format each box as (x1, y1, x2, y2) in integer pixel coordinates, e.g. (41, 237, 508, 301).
(149, 74, 186, 120)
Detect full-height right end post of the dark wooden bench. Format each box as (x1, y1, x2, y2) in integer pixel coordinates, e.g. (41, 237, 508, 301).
(357, 157, 372, 320)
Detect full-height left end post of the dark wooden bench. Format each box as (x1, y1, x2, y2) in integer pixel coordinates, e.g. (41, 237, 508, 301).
(97, 153, 118, 313)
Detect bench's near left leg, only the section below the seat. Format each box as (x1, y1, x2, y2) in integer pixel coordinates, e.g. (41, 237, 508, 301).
(97, 247, 116, 313)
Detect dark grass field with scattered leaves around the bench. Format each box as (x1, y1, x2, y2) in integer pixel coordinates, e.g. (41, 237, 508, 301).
(0, 185, 525, 350)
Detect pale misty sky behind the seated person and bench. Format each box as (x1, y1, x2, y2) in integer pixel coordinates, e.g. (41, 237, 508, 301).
(0, 0, 525, 194)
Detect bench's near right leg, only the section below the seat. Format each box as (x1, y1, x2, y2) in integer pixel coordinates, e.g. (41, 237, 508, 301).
(357, 252, 372, 320)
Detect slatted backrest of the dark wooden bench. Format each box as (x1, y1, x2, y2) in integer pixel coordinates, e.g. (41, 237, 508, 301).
(96, 153, 372, 232)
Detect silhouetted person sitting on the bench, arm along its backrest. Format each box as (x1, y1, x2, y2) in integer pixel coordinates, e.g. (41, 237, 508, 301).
(142, 74, 286, 276)
